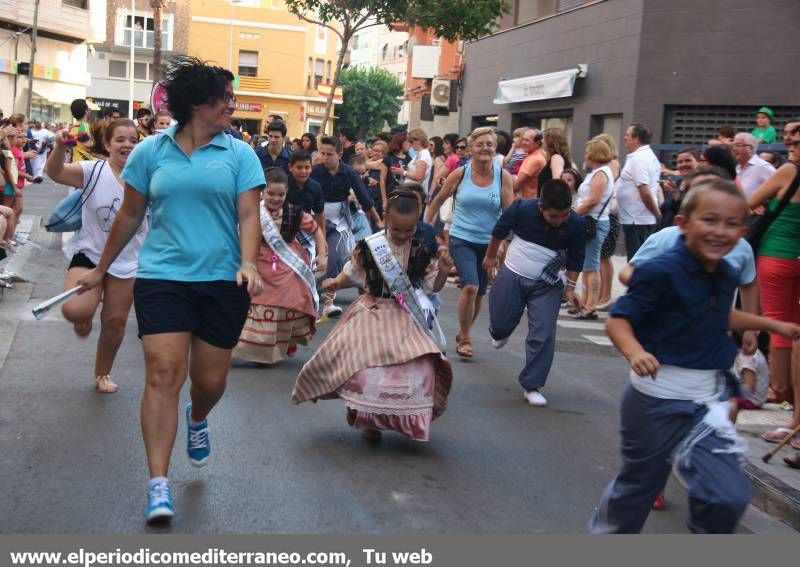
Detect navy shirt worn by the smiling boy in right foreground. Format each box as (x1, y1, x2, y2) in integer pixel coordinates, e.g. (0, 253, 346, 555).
(610, 238, 739, 370)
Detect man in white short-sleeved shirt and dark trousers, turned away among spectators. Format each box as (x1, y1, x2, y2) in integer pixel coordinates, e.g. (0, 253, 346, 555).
(614, 122, 661, 261)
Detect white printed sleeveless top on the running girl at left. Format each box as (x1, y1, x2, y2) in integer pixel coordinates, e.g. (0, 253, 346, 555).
(64, 160, 148, 279)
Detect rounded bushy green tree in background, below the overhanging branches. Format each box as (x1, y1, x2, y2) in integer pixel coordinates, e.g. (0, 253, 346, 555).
(336, 67, 404, 138)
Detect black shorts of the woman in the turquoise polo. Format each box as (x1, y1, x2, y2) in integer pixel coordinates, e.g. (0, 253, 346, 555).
(133, 278, 250, 349)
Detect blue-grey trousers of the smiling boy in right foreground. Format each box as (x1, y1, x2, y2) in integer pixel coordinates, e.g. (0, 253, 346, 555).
(589, 384, 753, 534)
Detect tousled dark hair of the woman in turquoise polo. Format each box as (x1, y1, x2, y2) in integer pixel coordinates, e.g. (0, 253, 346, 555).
(162, 55, 234, 129)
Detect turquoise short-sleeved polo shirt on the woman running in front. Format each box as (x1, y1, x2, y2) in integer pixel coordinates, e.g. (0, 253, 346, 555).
(122, 126, 266, 282)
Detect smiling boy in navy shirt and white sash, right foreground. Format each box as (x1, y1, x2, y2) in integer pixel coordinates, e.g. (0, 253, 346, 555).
(589, 179, 800, 533)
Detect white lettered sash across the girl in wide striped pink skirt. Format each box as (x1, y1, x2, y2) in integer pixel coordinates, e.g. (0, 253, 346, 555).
(365, 231, 447, 347)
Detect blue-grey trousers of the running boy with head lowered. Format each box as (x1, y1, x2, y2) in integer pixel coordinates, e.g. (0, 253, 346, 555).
(489, 265, 563, 392)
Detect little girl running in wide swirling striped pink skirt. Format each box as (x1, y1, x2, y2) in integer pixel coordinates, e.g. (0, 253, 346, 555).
(292, 191, 452, 441)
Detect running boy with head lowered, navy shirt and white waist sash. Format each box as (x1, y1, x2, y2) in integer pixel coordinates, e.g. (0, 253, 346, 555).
(483, 179, 586, 406)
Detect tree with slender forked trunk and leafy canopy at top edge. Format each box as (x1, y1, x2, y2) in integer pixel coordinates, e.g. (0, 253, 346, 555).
(285, 0, 509, 132)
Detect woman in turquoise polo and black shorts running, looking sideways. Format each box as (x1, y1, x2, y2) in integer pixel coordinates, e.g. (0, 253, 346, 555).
(77, 57, 265, 522)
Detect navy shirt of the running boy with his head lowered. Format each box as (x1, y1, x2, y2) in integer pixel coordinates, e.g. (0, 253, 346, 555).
(490, 197, 586, 272)
